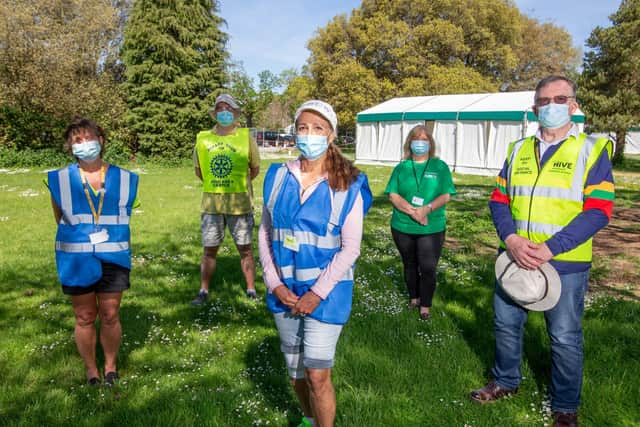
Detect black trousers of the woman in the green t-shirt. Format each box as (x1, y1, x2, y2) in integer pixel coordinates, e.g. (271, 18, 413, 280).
(391, 228, 444, 307)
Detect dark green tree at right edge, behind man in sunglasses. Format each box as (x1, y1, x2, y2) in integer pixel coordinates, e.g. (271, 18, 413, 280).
(579, 0, 640, 163)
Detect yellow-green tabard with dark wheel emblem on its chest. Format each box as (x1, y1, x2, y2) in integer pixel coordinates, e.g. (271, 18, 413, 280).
(196, 128, 249, 193)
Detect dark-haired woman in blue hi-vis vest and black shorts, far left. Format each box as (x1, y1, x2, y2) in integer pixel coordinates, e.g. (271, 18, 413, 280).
(47, 118, 138, 386)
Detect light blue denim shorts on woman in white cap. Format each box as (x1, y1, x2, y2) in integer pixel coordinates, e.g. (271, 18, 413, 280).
(273, 312, 343, 379)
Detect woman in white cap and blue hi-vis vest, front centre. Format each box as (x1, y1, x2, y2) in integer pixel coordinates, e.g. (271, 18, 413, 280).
(259, 100, 372, 426)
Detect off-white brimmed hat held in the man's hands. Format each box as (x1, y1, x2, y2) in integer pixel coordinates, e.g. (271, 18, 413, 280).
(496, 251, 562, 311)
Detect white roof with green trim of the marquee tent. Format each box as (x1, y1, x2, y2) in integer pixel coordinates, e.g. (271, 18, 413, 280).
(357, 91, 584, 123)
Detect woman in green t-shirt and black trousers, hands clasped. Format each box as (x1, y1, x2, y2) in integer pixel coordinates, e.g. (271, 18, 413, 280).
(385, 125, 456, 320)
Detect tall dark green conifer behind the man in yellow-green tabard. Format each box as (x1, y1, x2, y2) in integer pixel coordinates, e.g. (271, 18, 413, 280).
(122, 0, 227, 158)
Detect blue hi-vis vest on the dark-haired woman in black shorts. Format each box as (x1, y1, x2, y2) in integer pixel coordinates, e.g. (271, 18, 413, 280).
(48, 163, 138, 286)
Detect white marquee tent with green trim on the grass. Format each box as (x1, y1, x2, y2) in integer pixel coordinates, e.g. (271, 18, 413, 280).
(356, 91, 584, 175)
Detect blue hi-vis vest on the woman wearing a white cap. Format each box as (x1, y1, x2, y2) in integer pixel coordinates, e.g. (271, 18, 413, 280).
(263, 164, 372, 325)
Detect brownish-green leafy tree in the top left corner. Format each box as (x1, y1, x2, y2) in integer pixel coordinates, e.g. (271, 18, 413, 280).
(0, 0, 125, 149)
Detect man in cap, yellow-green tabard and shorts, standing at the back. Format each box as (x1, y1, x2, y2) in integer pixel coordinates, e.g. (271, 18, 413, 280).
(191, 94, 260, 305)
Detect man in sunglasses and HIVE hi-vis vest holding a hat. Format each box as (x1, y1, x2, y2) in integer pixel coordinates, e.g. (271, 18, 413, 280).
(471, 76, 614, 426)
